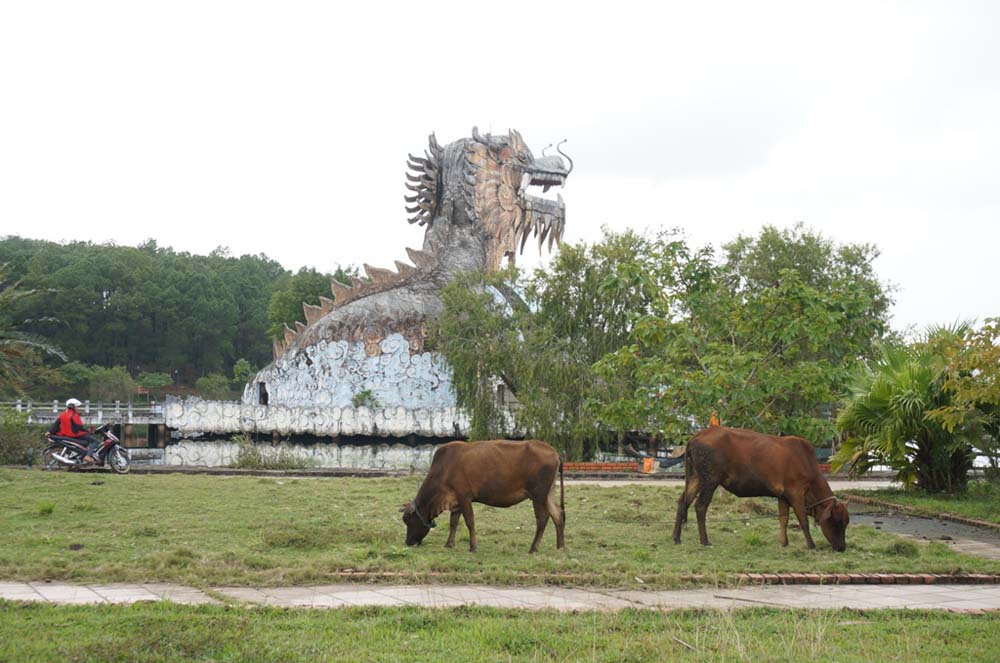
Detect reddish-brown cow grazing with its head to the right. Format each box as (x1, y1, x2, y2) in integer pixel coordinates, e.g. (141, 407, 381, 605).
(674, 427, 850, 552)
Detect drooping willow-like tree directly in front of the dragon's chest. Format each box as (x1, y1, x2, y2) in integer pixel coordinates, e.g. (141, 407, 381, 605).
(430, 230, 684, 458)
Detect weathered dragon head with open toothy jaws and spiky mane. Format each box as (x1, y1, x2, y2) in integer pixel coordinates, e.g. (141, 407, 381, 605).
(406, 127, 573, 270)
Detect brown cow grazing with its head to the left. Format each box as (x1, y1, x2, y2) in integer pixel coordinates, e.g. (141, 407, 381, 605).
(400, 440, 566, 552)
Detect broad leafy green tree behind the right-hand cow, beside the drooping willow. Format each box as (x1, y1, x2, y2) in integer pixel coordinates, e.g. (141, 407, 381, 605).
(595, 227, 891, 441)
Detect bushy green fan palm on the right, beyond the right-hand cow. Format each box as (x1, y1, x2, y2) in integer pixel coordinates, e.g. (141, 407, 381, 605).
(831, 325, 973, 492)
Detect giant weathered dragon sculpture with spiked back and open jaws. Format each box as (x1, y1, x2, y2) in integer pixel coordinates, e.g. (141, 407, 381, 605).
(225, 128, 573, 436)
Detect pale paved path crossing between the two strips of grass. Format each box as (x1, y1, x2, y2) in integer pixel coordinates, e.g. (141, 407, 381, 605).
(0, 582, 1000, 613)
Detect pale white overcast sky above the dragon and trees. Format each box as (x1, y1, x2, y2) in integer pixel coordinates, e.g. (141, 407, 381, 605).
(0, 0, 1000, 329)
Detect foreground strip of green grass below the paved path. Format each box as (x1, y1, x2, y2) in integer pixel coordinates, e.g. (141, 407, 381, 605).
(0, 601, 1000, 662)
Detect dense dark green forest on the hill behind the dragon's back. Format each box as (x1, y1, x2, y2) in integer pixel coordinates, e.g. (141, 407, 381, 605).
(0, 237, 354, 400)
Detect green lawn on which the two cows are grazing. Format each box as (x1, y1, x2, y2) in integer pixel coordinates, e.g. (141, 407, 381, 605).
(0, 470, 1000, 588)
